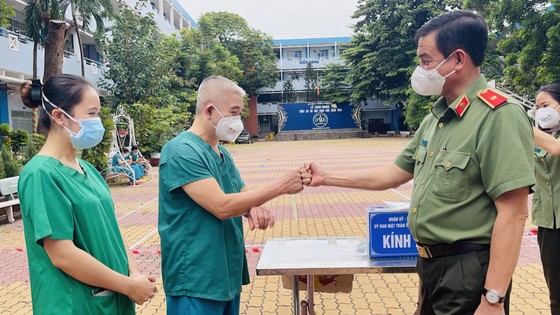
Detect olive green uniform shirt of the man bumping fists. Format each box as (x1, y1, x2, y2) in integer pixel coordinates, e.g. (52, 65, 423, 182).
(395, 75, 535, 245)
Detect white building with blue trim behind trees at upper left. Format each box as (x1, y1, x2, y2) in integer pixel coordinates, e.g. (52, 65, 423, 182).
(0, 0, 198, 132)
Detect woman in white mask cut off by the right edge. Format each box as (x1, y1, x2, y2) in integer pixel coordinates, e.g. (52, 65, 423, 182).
(532, 83, 560, 315)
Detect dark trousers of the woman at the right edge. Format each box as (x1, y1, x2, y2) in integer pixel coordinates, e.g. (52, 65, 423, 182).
(537, 227, 560, 315)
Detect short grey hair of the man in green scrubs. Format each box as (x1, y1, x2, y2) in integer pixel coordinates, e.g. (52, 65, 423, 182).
(196, 75, 246, 114)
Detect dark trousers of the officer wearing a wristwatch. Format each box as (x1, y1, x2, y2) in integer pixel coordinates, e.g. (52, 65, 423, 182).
(415, 249, 511, 315)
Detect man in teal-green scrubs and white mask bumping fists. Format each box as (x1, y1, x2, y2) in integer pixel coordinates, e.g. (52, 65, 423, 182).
(158, 76, 303, 315)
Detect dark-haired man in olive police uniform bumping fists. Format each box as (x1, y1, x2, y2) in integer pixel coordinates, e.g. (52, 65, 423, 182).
(304, 11, 535, 315)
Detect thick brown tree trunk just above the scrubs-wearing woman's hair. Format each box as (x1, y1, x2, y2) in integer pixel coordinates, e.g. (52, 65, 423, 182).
(43, 20, 70, 82)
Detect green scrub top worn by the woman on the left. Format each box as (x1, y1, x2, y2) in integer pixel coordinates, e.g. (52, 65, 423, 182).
(18, 155, 135, 315)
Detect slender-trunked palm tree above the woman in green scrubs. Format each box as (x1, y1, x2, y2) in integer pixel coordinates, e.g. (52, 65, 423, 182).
(61, 0, 114, 77)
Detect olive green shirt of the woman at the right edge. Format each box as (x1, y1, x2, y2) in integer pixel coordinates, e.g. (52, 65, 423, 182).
(531, 134, 560, 229)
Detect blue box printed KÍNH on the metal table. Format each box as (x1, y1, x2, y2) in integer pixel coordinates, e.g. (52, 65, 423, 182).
(366, 202, 418, 259)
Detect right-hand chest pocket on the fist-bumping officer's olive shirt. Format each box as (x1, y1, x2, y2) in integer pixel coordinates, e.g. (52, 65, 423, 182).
(432, 151, 471, 202)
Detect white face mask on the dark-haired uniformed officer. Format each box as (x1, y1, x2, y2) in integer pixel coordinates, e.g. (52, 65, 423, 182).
(410, 52, 455, 96)
